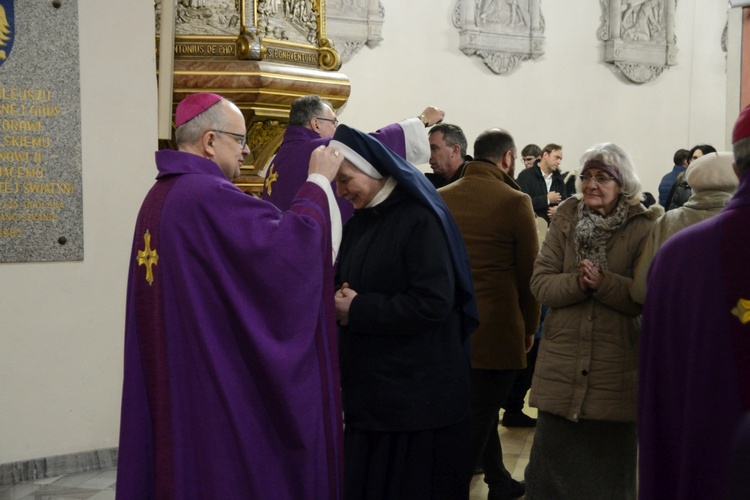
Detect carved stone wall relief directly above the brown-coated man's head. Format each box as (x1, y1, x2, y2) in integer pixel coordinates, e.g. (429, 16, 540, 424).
(453, 0, 544, 75)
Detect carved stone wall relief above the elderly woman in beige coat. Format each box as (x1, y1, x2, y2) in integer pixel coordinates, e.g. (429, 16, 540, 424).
(597, 0, 677, 83)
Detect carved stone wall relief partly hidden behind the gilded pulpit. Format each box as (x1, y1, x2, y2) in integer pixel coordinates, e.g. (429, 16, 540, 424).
(326, 0, 385, 62)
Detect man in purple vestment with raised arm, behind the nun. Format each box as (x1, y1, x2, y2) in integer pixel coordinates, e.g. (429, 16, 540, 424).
(263, 95, 445, 223)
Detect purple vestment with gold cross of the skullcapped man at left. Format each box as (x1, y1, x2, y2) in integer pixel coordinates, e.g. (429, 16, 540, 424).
(117, 151, 342, 500)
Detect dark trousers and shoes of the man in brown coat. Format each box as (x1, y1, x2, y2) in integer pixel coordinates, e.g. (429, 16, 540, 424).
(467, 369, 521, 492)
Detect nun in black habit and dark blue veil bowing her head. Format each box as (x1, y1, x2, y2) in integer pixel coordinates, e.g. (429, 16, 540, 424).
(330, 125, 478, 500)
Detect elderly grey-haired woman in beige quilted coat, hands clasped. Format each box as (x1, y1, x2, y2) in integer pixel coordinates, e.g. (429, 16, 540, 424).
(526, 143, 660, 500)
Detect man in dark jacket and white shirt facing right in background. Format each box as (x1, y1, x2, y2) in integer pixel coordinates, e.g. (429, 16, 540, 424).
(517, 144, 568, 224)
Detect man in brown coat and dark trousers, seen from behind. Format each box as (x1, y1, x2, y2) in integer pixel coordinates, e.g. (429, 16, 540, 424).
(438, 129, 540, 500)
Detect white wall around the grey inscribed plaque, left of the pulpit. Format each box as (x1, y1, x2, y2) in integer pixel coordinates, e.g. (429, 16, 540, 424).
(0, 0, 157, 463)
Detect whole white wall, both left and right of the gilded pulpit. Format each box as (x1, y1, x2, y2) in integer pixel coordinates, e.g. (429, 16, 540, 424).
(0, 0, 736, 463)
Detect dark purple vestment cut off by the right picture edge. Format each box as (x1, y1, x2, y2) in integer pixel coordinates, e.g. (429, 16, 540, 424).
(638, 172, 750, 500)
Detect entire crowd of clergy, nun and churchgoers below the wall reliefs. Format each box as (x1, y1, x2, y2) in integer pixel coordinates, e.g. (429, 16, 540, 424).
(117, 93, 750, 500)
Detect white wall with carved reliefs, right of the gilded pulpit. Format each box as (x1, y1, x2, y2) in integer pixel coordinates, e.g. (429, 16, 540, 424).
(340, 0, 736, 196)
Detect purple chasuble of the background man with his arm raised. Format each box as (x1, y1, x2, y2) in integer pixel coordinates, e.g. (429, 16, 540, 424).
(263, 123, 406, 224)
